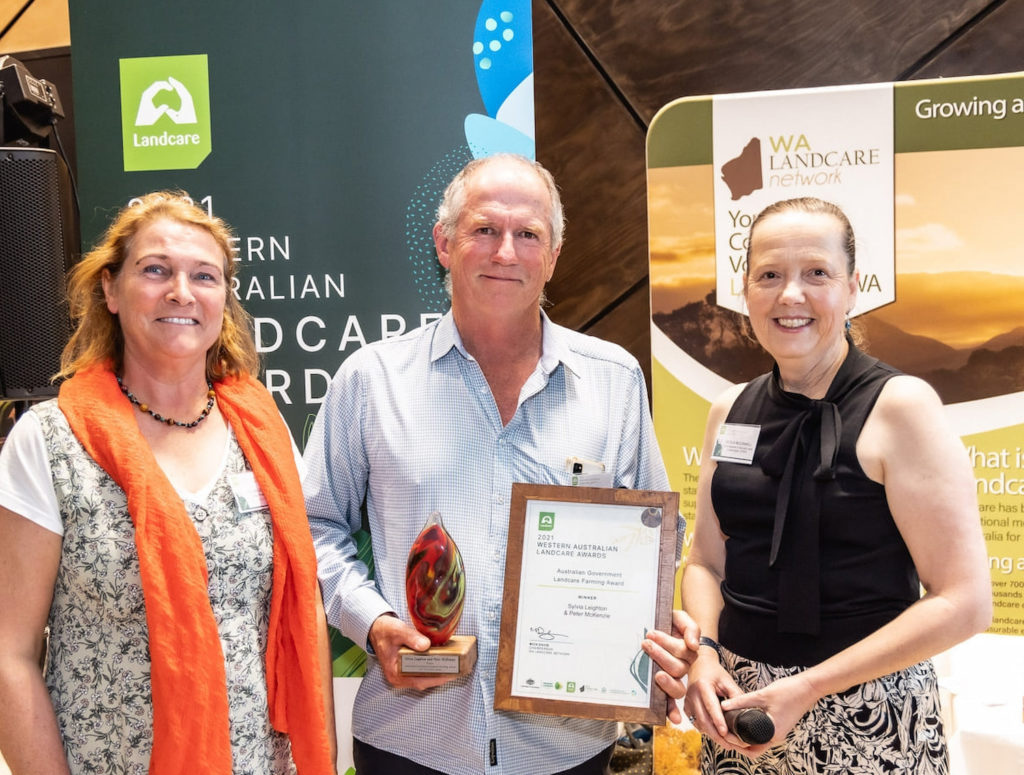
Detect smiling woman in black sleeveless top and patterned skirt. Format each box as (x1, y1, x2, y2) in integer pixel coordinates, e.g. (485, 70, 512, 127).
(682, 199, 991, 773)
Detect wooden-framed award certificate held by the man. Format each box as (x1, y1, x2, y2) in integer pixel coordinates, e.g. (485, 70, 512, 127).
(495, 484, 679, 724)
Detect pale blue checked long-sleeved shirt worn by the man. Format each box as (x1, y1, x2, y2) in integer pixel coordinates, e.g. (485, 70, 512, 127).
(303, 312, 669, 775)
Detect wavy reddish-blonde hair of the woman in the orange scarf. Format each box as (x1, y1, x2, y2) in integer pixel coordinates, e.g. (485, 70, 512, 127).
(56, 191, 260, 381)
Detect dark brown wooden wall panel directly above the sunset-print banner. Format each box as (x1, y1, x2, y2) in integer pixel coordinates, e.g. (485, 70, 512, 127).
(539, 0, 990, 121)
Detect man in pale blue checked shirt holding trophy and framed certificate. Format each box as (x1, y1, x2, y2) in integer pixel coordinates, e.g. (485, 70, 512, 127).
(304, 155, 698, 775)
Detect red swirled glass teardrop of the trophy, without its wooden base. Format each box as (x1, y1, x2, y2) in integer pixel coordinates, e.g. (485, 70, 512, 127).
(406, 511, 466, 646)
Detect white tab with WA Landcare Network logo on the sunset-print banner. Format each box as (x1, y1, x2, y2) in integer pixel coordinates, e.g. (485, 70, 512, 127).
(712, 84, 895, 313)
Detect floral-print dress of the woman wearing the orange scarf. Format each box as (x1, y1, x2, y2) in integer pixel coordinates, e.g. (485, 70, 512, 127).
(32, 400, 295, 775)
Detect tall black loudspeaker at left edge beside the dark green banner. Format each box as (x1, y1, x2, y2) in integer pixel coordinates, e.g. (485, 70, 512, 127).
(0, 146, 77, 400)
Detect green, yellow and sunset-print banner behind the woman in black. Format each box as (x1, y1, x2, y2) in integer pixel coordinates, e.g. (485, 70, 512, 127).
(647, 74, 1024, 757)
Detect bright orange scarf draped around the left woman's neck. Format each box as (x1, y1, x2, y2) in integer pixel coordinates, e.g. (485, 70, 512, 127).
(57, 364, 333, 775)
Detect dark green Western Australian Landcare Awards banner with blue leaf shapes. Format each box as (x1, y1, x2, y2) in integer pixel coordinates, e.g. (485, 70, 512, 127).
(71, 0, 535, 772)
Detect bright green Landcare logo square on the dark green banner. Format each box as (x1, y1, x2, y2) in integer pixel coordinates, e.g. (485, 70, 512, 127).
(121, 54, 213, 172)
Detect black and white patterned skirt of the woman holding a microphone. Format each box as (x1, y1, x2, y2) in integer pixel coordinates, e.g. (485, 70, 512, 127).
(700, 648, 949, 775)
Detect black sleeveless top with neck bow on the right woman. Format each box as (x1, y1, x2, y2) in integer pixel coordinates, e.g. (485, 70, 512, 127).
(711, 342, 921, 666)
